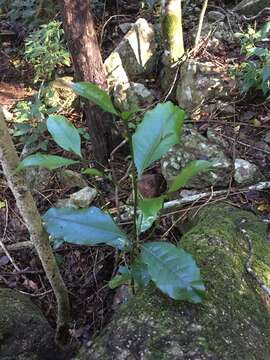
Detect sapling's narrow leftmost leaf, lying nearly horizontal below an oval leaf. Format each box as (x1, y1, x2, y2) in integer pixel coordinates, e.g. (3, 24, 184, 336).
(16, 153, 78, 171)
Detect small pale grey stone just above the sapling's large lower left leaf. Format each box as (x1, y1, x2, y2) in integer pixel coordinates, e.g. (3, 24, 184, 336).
(55, 186, 97, 209)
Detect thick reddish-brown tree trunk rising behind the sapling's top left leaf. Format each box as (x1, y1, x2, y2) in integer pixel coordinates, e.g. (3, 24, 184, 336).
(60, 0, 113, 166)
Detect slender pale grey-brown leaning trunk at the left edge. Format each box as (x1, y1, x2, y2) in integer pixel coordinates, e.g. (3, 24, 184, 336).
(0, 108, 70, 345)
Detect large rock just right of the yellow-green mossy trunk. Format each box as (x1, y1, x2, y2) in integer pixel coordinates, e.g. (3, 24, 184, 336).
(176, 60, 235, 112)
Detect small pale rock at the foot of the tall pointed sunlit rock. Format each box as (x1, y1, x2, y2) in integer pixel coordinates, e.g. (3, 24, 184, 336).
(113, 82, 154, 111)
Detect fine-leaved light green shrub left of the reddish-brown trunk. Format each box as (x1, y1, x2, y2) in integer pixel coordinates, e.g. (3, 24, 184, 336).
(24, 21, 70, 82)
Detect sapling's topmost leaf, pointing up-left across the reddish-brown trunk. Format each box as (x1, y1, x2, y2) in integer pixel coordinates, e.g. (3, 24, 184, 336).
(69, 82, 119, 116)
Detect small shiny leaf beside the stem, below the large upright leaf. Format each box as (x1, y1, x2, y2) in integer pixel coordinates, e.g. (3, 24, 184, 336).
(138, 196, 164, 232)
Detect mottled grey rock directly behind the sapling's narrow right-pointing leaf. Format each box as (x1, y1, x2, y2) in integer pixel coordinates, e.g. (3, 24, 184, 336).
(161, 127, 233, 189)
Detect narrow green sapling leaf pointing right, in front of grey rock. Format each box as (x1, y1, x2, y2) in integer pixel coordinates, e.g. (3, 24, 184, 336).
(168, 160, 212, 193)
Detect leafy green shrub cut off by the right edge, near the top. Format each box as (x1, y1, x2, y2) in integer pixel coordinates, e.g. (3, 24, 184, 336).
(233, 21, 270, 99)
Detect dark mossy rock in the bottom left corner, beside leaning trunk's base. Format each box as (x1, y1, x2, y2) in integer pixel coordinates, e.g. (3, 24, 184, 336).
(0, 288, 64, 360)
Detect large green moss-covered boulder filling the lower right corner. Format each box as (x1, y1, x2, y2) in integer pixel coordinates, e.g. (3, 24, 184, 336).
(77, 204, 270, 360)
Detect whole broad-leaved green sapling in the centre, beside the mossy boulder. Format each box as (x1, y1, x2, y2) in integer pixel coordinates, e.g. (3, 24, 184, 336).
(17, 83, 211, 303)
